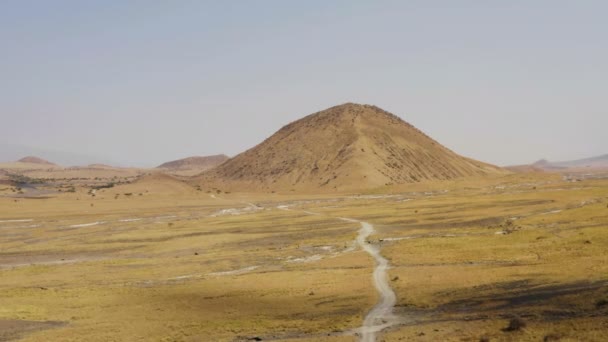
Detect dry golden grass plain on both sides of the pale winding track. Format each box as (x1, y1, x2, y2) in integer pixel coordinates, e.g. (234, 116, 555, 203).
(0, 174, 608, 341)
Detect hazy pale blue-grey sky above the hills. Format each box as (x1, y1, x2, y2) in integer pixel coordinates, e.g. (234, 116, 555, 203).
(0, 0, 608, 166)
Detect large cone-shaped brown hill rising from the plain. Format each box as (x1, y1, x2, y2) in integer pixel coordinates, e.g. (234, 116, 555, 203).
(197, 103, 507, 191)
